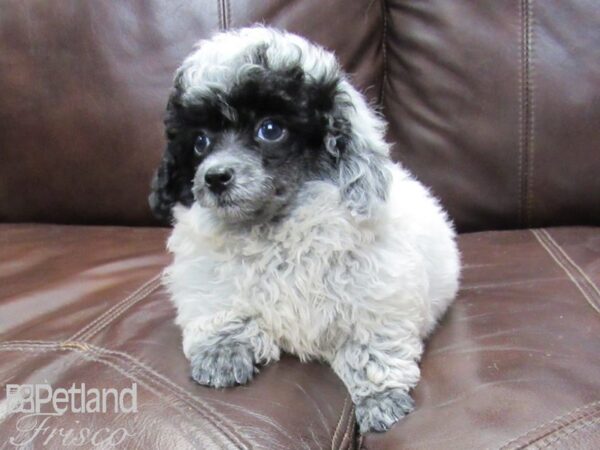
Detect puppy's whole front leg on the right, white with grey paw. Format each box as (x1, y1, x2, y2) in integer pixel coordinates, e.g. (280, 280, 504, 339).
(331, 330, 423, 434)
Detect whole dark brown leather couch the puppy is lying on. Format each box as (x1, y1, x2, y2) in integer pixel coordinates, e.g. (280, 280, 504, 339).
(0, 0, 600, 450)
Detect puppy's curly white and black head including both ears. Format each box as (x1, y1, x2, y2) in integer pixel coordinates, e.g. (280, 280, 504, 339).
(150, 27, 390, 224)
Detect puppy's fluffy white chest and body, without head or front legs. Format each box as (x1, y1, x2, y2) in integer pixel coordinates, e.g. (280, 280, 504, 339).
(166, 174, 458, 358)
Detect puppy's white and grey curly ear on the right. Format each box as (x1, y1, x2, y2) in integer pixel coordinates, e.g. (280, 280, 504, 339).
(325, 81, 392, 218)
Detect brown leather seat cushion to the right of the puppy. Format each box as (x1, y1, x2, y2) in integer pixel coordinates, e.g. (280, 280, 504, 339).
(363, 228, 600, 450)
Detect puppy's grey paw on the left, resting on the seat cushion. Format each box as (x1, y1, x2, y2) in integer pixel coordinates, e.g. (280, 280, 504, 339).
(190, 342, 257, 388)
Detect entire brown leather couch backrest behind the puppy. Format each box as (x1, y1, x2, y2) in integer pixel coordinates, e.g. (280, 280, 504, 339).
(0, 0, 600, 231)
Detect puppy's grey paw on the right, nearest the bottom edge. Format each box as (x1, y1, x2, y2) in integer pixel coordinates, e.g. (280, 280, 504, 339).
(356, 389, 414, 434)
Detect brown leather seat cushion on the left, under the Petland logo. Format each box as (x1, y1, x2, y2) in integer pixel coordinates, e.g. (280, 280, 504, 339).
(0, 225, 354, 449)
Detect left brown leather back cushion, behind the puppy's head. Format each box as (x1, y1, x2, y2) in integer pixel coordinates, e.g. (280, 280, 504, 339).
(0, 0, 383, 225)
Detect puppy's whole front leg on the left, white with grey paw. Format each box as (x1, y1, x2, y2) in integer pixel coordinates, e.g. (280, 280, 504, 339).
(183, 313, 279, 388)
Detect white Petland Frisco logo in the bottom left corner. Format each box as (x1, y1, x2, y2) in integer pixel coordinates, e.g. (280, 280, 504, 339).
(0, 383, 137, 448)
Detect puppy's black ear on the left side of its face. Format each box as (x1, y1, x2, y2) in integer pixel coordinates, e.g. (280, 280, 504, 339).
(148, 97, 194, 223)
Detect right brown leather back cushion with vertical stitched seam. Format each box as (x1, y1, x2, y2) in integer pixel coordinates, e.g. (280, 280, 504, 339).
(383, 0, 600, 231)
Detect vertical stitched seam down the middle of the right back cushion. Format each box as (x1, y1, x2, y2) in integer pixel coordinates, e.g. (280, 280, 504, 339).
(527, 0, 535, 226)
